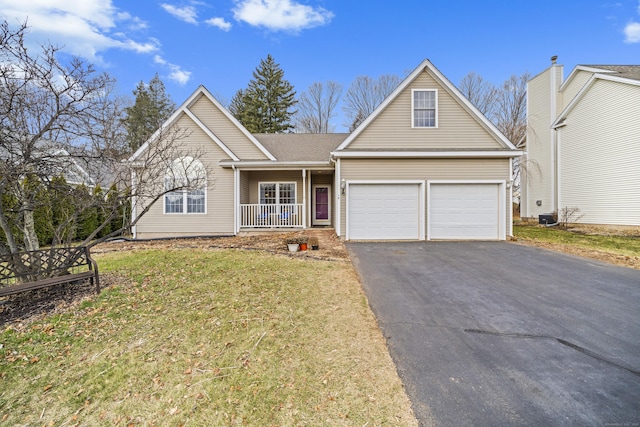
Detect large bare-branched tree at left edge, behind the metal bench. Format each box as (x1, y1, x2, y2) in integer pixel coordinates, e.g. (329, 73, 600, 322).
(0, 21, 201, 252)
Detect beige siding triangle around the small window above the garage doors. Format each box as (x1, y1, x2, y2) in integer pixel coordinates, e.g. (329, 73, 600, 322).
(348, 71, 504, 150)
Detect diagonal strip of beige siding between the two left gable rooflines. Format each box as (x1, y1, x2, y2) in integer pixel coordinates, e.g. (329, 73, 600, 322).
(189, 96, 268, 160)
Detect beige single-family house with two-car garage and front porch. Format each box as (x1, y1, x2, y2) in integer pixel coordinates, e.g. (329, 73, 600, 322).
(134, 60, 521, 240)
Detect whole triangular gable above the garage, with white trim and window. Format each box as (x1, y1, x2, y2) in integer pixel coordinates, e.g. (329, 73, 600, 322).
(336, 60, 515, 152)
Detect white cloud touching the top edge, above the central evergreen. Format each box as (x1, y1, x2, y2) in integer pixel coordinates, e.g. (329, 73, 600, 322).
(233, 0, 333, 32)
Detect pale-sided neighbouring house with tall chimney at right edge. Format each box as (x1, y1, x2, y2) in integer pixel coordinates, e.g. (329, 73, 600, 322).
(521, 61, 640, 226)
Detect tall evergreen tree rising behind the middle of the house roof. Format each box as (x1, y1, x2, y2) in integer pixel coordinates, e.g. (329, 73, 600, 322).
(229, 55, 297, 133)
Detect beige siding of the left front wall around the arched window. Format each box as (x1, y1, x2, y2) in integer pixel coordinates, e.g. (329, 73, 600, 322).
(137, 116, 234, 238)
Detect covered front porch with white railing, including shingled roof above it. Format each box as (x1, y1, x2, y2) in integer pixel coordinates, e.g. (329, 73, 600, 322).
(220, 133, 347, 233)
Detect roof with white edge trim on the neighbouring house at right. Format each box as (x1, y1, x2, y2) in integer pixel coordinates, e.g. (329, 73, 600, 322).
(551, 65, 640, 129)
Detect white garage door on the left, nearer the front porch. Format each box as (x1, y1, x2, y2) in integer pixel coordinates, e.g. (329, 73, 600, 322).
(347, 184, 421, 240)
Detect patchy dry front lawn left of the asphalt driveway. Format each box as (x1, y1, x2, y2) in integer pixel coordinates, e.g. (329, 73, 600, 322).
(0, 248, 417, 426)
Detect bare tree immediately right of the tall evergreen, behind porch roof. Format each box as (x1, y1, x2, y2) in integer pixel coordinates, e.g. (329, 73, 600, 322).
(295, 81, 342, 133)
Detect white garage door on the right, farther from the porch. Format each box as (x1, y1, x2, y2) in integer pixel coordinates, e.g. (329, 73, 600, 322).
(429, 184, 500, 240)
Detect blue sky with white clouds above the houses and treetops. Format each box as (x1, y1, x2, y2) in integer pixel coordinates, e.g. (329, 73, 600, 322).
(0, 0, 640, 131)
